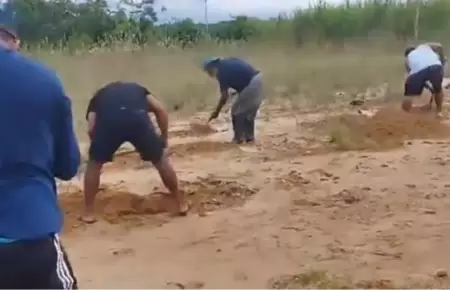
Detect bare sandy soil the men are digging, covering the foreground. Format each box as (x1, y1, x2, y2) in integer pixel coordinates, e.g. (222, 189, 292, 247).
(60, 99, 450, 288)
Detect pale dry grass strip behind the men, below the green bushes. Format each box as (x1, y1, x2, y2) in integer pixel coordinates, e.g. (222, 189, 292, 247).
(29, 45, 403, 139)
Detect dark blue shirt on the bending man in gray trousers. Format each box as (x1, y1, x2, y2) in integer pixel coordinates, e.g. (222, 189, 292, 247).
(217, 58, 259, 93)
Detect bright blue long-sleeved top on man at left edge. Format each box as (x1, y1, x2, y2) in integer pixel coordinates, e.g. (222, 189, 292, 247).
(0, 48, 80, 239)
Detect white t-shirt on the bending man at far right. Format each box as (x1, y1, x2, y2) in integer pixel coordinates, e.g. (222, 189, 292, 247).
(407, 44, 442, 74)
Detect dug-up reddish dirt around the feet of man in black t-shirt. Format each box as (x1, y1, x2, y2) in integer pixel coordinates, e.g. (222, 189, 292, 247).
(59, 177, 256, 233)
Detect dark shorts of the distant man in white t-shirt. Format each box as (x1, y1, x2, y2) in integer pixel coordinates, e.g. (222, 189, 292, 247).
(405, 65, 444, 97)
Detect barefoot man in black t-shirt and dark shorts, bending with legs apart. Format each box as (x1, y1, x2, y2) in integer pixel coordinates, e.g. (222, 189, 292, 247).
(82, 82, 188, 223)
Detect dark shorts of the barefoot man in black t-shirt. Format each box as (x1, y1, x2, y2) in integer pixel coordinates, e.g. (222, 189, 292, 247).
(89, 112, 164, 164)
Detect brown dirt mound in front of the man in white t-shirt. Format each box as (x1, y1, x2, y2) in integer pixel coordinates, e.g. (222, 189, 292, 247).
(326, 108, 450, 150)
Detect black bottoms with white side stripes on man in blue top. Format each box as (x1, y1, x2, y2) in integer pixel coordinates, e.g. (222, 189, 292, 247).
(0, 236, 78, 289)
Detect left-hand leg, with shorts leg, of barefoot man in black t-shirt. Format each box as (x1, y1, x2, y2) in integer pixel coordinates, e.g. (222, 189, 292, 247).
(81, 124, 123, 223)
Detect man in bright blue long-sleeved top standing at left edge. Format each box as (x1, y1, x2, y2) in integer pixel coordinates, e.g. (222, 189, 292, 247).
(0, 27, 80, 289)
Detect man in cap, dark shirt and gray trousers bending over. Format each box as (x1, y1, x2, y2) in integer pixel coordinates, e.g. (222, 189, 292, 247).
(203, 58, 262, 144)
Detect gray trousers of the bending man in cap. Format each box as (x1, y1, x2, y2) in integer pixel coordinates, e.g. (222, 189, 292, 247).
(231, 73, 263, 143)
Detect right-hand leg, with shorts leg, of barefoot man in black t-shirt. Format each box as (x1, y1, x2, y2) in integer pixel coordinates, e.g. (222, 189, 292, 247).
(127, 120, 189, 215)
